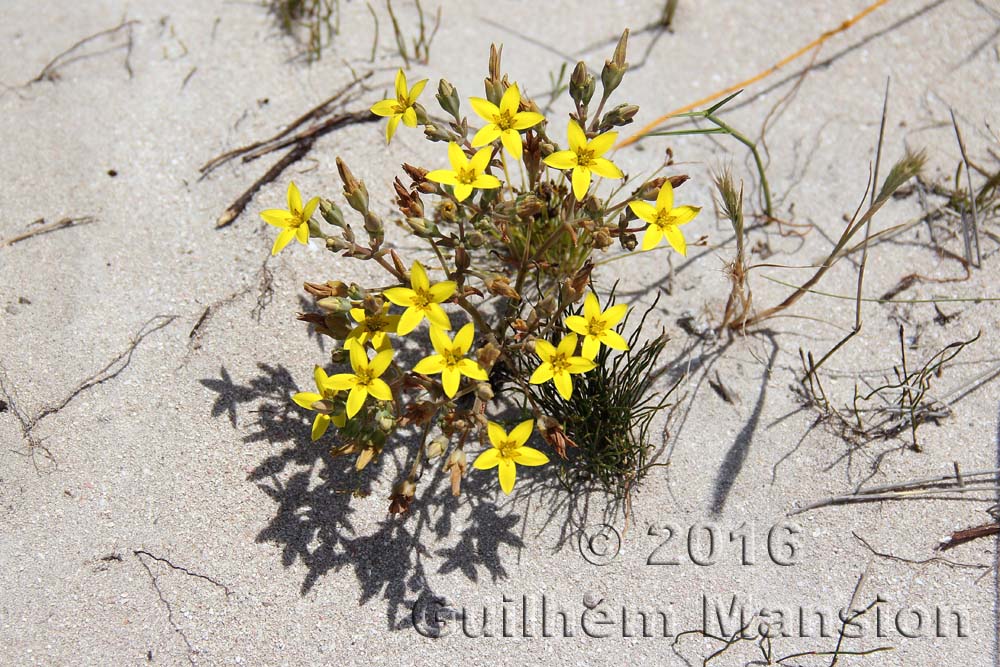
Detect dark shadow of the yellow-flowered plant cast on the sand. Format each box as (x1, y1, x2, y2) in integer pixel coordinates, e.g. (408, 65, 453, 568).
(199, 364, 615, 634)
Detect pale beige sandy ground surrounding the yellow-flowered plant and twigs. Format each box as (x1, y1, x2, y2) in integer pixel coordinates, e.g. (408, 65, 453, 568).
(0, 0, 1000, 667)
